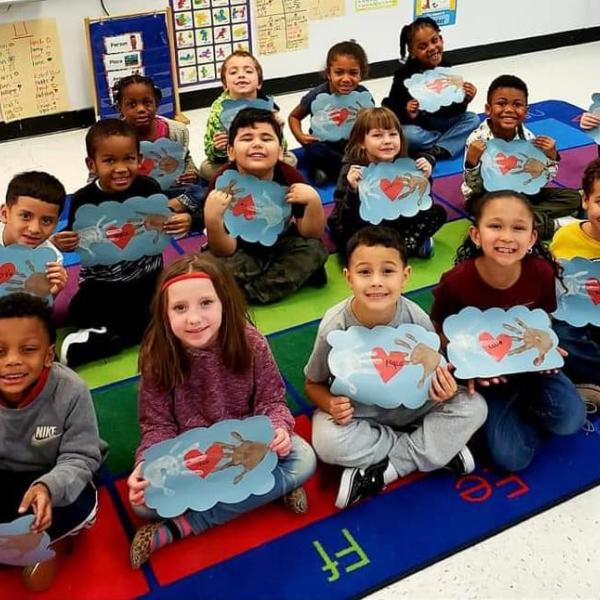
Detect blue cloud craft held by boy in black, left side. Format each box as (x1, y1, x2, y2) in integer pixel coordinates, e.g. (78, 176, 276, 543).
(73, 194, 172, 267)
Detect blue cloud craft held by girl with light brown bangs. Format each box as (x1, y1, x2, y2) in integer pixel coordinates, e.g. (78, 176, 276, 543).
(358, 158, 431, 225)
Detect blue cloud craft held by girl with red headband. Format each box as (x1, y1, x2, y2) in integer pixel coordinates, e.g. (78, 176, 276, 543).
(142, 416, 278, 518)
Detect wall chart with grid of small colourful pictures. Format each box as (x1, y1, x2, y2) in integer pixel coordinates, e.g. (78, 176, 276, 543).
(170, 0, 252, 87)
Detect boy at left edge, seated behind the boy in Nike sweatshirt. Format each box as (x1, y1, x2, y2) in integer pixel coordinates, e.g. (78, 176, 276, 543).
(0, 171, 67, 296)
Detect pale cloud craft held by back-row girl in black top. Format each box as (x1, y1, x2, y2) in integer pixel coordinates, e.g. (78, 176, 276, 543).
(404, 67, 465, 113)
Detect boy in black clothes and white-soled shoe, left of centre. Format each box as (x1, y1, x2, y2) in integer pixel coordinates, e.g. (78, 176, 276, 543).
(53, 119, 192, 367)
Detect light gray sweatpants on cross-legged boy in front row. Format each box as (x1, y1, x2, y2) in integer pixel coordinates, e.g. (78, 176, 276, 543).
(312, 387, 487, 477)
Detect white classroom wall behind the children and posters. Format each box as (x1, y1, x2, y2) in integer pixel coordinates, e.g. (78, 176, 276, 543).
(0, 0, 600, 120)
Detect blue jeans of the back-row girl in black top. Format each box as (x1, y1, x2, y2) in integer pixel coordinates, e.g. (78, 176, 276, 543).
(402, 112, 479, 156)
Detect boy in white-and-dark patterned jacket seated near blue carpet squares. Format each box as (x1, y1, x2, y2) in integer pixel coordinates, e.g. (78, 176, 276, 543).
(462, 75, 580, 239)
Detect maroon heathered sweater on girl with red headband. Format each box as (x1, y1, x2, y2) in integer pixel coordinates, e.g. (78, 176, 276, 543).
(136, 324, 294, 463)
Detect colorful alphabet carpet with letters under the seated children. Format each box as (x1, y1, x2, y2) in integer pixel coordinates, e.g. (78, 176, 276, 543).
(0, 101, 600, 600)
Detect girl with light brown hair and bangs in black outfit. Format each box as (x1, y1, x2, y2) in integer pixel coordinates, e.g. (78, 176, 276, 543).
(328, 108, 447, 258)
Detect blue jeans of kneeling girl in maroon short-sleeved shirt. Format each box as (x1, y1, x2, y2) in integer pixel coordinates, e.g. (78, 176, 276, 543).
(480, 372, 585, 471)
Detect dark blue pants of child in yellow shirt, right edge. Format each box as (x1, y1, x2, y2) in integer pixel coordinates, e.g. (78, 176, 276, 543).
(552, 321, 600, 385)
